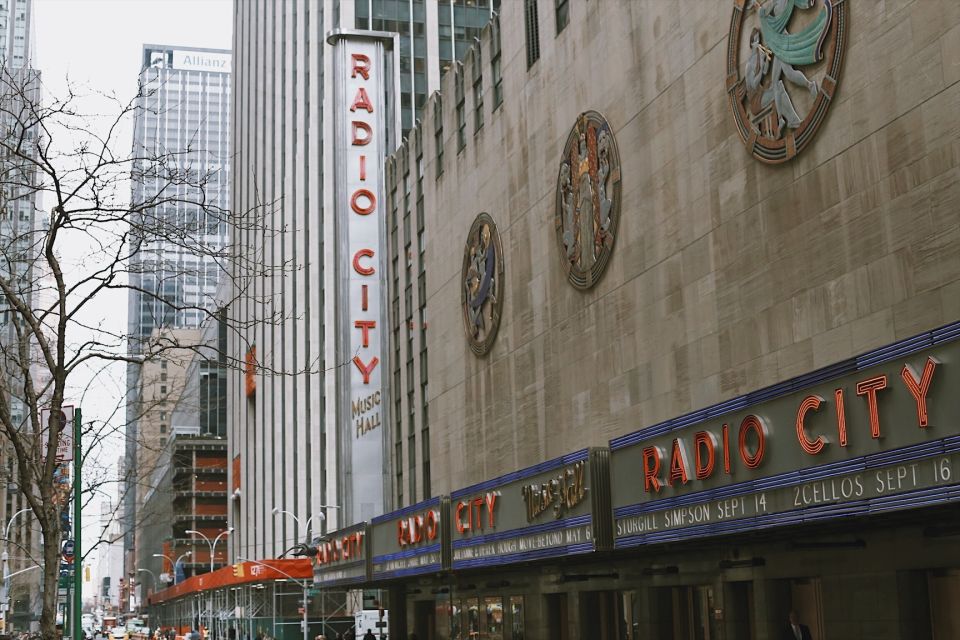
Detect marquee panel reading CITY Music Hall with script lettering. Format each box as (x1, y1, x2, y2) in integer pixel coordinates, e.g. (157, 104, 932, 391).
(450, 448, 610, 569)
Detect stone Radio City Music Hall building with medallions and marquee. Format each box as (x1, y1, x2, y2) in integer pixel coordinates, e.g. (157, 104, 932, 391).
(369, 0, 960, 640)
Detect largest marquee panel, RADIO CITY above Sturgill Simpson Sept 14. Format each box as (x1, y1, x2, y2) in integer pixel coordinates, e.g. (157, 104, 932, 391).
(610, 331, 960, 547)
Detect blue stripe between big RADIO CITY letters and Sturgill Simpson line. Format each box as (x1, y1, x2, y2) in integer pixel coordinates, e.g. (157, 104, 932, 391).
(613, 436, 960, 518)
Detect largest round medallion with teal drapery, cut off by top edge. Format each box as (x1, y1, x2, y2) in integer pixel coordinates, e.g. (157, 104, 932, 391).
(727, 0, 847, 164)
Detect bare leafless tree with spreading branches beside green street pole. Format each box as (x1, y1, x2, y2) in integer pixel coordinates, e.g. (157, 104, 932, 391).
(0, 61, 288, 640)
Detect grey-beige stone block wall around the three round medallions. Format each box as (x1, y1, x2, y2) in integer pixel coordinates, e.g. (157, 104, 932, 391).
(386, 0, 960, 495)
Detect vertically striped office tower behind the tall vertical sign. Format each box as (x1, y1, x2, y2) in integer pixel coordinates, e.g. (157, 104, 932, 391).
(228, 0, 494, 558)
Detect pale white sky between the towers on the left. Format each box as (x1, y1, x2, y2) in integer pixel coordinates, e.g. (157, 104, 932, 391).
(33, 0, 232, 595)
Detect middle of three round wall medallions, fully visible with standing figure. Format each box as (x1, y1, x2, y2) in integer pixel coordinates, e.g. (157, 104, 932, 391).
(554, 111, 620, 289)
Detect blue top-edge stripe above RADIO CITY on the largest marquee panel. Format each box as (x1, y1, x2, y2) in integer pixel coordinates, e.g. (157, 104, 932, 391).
(610, 322, 960, 451)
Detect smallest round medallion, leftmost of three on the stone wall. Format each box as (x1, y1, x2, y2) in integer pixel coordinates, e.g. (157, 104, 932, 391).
(460, 213, 503, 356)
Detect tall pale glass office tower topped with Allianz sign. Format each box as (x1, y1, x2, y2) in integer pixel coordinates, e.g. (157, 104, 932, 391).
(124, 44, 231, 592)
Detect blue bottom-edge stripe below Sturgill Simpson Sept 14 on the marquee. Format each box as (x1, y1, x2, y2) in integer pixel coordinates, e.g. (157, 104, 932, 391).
(614, 485, 960, 549)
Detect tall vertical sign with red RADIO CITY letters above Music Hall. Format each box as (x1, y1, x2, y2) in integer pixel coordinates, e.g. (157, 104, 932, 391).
(327, 30, 397, 523)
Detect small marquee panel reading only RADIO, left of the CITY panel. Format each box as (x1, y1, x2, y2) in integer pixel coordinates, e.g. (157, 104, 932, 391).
(370, 498, 449, 580)
